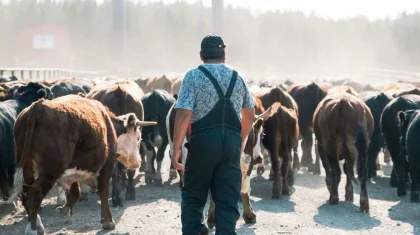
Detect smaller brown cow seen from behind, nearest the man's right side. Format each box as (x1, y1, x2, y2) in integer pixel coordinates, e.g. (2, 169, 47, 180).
(262, 102, 299, 199)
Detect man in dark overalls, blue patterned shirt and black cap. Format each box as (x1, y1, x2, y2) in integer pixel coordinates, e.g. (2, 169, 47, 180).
(172, 35, 255, 235)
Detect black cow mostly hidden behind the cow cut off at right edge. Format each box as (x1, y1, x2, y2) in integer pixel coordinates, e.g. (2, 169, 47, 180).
(380, 95, 420, 197)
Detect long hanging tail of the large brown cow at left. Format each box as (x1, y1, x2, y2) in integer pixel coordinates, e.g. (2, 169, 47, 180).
(8, 100, 42, 203)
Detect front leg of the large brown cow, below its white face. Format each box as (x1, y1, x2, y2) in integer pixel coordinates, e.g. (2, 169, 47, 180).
(98, 160, 115, 229)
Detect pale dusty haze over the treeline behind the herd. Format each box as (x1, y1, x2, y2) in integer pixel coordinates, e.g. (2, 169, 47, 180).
(0, 0, 420, 79)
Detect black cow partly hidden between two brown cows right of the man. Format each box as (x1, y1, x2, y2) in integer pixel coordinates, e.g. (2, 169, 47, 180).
(287, 82, 328, 174)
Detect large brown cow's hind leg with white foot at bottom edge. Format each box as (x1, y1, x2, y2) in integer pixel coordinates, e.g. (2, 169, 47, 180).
(25, 175, 56, 235)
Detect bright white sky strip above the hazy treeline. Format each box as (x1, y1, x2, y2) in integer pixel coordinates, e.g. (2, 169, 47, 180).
(0, 0, 420, 20)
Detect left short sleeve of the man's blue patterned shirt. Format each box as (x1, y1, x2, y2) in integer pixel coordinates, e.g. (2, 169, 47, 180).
(175, 72, 195, 111)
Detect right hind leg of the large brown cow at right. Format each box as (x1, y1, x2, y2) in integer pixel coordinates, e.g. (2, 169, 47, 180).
(351, 134, 369, 212)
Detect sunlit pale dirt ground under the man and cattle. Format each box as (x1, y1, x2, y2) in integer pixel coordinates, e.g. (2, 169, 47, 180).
(0, 145, 420, 235)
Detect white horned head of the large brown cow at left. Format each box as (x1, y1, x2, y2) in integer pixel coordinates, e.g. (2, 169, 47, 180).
(117, 113, 157, 170)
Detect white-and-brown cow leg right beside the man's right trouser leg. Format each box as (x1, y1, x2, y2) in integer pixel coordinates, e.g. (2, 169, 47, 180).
(241, 154, 257, 224)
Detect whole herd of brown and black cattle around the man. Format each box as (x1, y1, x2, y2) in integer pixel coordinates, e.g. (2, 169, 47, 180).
(0, 76, 420, 234)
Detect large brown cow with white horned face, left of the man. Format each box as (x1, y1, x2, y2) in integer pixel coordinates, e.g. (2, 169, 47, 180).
(10, 95, 156, 235)
